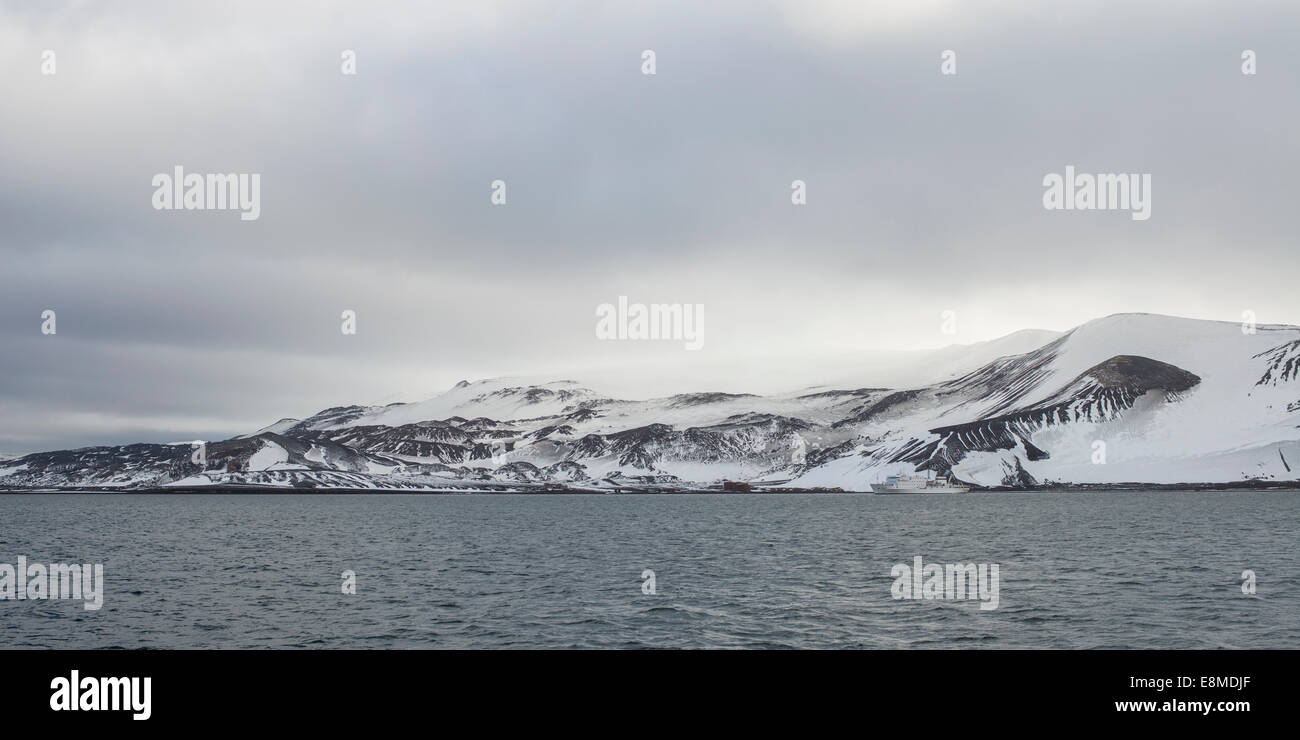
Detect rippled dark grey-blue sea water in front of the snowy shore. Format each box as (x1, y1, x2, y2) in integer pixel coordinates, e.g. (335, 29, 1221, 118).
(0, 492, 1300, 648)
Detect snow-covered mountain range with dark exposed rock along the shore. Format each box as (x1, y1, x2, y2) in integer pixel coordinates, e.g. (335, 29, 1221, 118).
(0, 313, 1300, 490)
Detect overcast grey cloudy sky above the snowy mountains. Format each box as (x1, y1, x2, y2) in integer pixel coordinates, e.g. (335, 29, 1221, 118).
(0, 0, 1300, 453)
